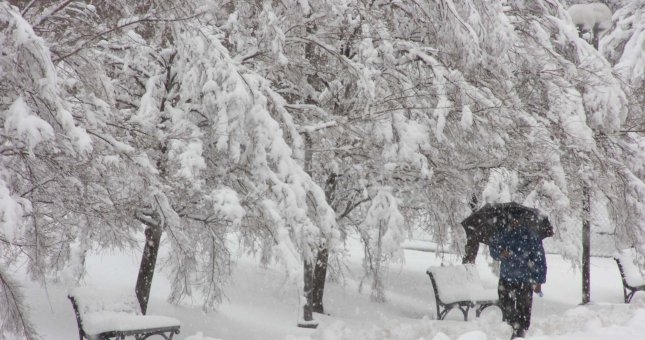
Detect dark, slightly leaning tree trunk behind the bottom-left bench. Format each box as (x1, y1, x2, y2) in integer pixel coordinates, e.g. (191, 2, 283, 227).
(135, 225, 161, 314)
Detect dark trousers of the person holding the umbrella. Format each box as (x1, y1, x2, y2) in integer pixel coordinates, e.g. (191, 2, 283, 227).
(497, 279, 533, 339)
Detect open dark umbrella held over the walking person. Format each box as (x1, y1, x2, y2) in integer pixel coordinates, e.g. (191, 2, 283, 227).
(461, 202, 553, 244)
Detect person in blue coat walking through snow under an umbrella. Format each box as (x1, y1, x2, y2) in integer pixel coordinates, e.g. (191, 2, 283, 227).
(489, 217, 546, 339)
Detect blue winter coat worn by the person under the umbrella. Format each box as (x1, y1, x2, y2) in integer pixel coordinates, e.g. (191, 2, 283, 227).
(489, 227, 546, 283)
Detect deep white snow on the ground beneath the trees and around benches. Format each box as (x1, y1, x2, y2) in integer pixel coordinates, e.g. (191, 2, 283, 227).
(15, 236, 645, 340)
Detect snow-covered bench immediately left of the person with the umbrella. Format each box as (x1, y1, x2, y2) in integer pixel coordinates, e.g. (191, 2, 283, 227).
(426, 264, 499, 321)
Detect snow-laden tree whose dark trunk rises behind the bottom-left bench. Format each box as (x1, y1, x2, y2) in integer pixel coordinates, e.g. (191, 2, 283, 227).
(3, 1, 335, 322)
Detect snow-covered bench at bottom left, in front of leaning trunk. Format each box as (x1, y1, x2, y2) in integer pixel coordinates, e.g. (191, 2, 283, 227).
(68, 287, 180, 340)
